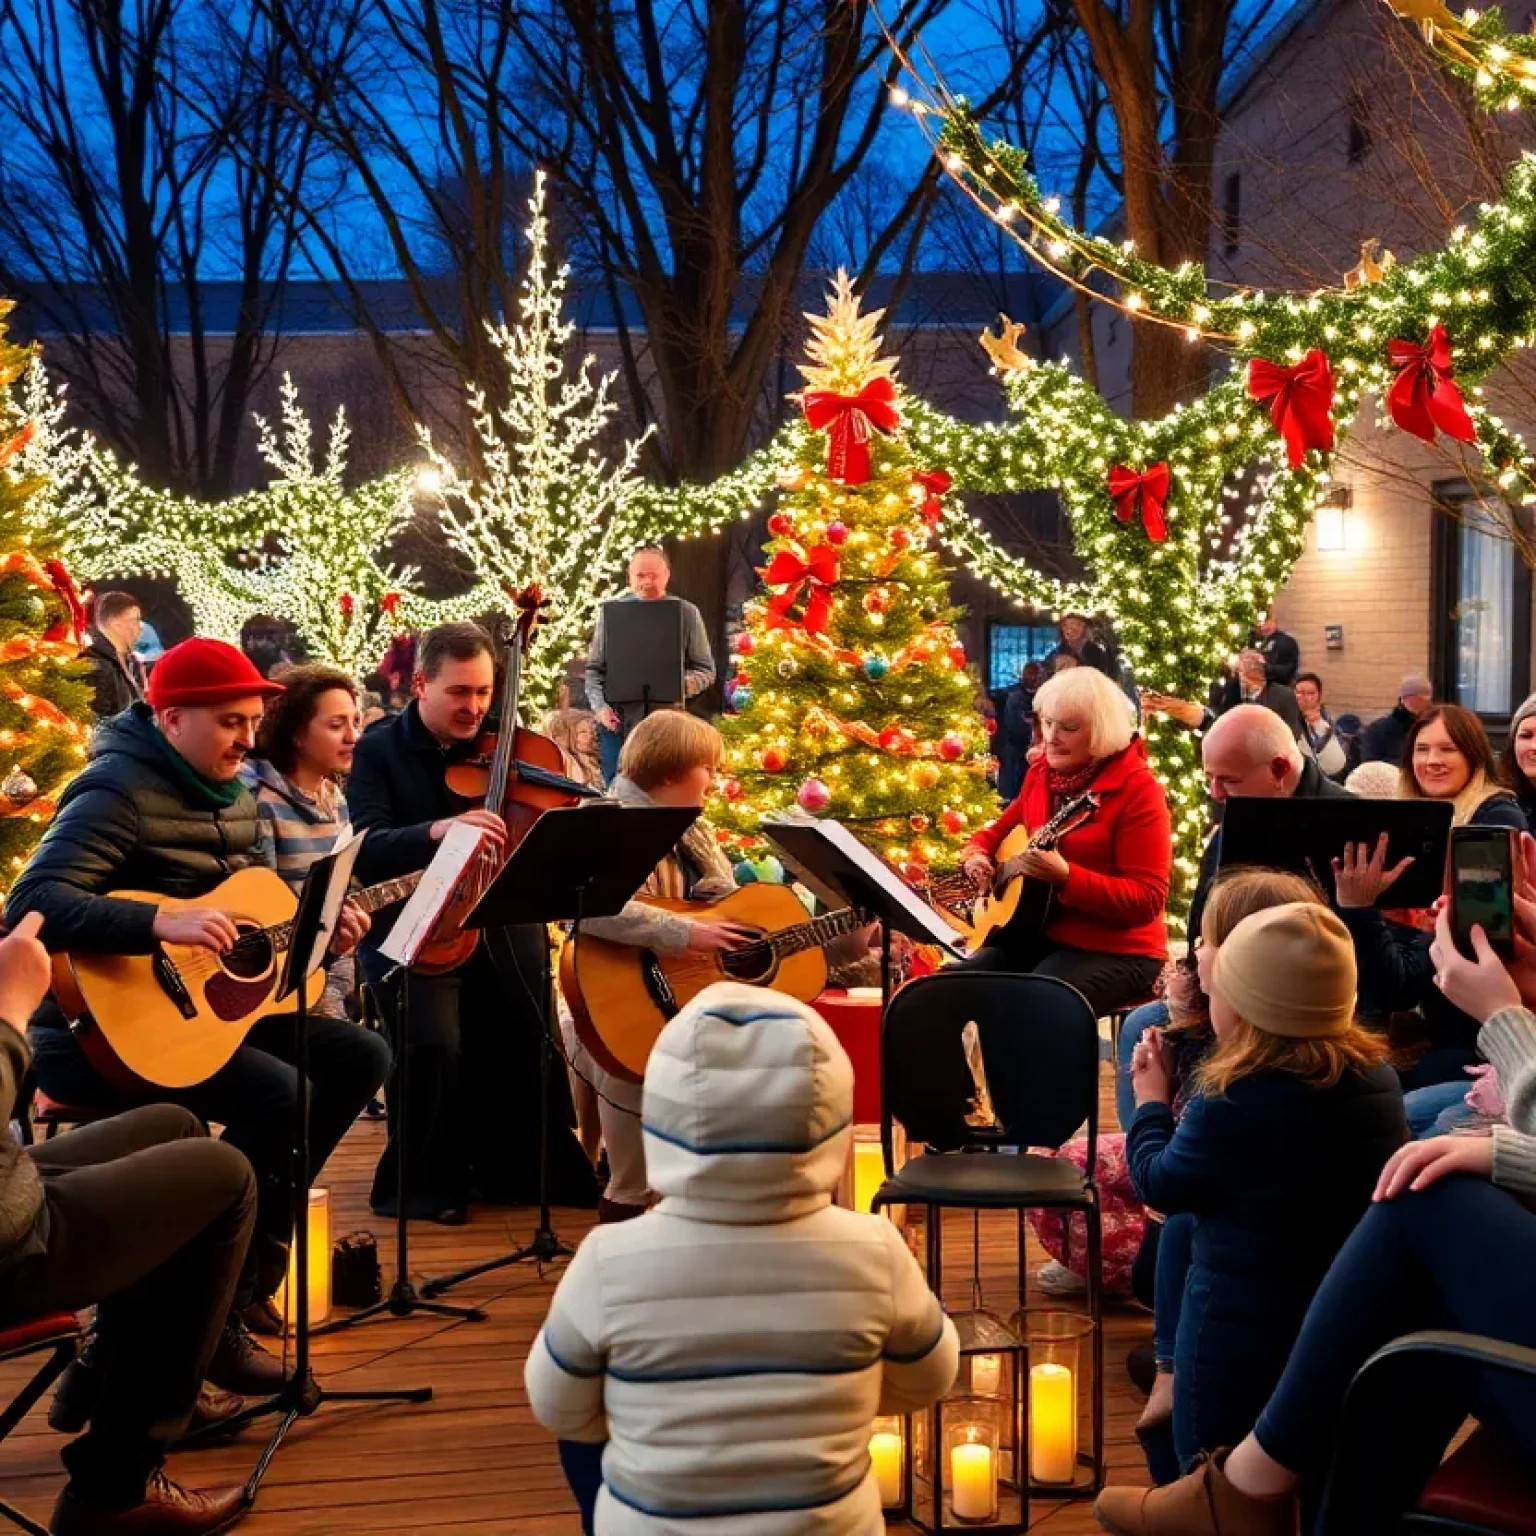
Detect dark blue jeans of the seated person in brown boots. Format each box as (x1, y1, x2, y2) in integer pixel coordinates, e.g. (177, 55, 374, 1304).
(1255, 1177, 1536, 1536)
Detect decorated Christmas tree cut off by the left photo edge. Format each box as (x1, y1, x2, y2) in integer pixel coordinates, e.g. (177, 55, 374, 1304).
(0, 301, 91, 889)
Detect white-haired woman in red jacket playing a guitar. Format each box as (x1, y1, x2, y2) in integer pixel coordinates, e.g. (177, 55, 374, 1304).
(963, 667, 1174, 1015)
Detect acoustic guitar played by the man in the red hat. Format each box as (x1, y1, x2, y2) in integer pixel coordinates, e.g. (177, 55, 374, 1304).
(54, 865, 421, 1094)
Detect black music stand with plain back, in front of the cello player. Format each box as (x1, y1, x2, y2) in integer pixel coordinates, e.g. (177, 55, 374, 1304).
(421, 800, 699, 1296)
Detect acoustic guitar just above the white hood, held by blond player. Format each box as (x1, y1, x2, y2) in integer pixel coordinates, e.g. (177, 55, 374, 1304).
(561, 883, 866, 1083)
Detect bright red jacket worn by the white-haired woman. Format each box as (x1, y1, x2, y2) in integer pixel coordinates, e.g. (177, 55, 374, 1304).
(966, 737, 1174, 958)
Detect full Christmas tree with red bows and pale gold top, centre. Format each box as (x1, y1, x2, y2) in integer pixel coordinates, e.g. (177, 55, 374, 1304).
(714, 272, 997, 882)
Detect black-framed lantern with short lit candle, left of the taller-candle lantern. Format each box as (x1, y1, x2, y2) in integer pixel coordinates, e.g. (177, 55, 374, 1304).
(908, 1310, 1029, 1531)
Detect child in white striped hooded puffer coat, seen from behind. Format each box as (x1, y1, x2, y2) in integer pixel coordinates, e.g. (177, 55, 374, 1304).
(524, 983, 958, 1536)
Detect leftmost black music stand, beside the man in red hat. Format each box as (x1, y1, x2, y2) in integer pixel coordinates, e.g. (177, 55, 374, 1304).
(187, 834, 432, 1504)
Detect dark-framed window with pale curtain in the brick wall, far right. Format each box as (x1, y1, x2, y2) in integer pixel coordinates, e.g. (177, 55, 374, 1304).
(1435, 481, 1531, 727)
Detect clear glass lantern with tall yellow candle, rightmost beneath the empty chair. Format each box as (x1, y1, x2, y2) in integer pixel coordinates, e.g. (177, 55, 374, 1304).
(1009, 1309, 1104, 1499)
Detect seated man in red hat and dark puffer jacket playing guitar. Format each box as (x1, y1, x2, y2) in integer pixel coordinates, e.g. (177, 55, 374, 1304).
(5, 639, 389, 1393)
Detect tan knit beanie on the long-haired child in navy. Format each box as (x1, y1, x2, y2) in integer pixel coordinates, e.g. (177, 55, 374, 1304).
(1210, 902, 1355, 1040)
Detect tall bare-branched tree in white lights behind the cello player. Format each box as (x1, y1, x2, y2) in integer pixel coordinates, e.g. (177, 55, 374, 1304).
(421, 170, 650, 711)
